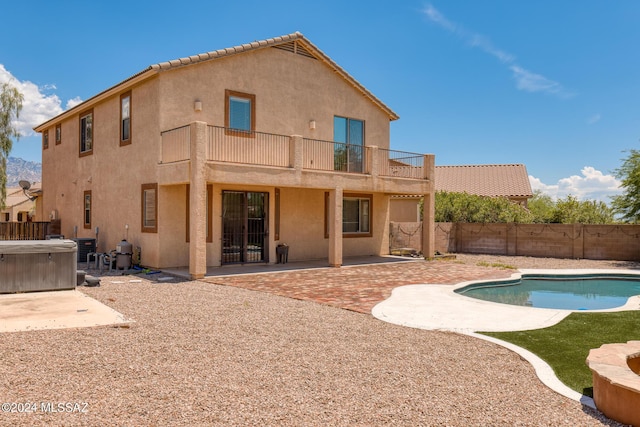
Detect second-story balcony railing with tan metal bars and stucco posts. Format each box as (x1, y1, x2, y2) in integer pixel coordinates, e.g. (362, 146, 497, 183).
(161, 124, 433, 191)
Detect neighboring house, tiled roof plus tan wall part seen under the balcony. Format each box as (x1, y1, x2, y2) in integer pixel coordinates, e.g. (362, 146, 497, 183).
(391, 164, 533, 222)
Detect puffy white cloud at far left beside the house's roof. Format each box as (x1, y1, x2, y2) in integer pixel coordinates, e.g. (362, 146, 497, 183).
(0, 64, 81, 136)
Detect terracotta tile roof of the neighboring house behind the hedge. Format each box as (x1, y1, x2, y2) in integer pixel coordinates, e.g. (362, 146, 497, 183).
(435, 164, 533, 197)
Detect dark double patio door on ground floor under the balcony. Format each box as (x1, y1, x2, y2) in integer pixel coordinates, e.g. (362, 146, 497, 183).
(221, 190, 269, 265)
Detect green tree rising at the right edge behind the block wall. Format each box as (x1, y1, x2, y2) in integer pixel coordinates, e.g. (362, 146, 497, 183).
(611, 149, 640, 223)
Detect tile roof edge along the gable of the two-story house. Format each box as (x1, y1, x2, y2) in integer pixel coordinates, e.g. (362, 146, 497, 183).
(34, 32, 400, 132)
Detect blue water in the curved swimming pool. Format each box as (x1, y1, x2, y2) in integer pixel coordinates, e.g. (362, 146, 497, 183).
(456, 274, 640, 310)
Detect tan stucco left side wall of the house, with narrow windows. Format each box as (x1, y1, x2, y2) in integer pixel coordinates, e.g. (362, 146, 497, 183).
(42, 79, 160, 265)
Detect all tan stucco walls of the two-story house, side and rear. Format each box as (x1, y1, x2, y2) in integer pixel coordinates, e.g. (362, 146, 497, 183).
(43, 44, 430, 268)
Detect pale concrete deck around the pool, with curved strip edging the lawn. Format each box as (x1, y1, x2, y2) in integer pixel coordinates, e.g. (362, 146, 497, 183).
(371, 269, 640, 409)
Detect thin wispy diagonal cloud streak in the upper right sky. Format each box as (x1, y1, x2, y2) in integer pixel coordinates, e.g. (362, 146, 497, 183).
(423, 4, 573, 98)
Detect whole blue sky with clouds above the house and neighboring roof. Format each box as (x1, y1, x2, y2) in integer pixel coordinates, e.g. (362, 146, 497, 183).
(0, 0, 640, 201)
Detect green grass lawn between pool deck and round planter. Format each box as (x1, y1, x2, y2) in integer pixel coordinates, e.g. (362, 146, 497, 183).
(480, 311, 640, 397)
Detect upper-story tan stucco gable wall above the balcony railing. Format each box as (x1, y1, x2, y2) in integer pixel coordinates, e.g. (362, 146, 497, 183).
(159, 48, 389, 148)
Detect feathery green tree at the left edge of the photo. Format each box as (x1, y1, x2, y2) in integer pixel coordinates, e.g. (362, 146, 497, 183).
(0, 83, 24, 208)
